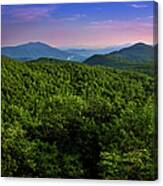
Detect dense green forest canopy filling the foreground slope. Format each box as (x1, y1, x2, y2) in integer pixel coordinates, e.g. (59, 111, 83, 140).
(2, 57, 157, 180)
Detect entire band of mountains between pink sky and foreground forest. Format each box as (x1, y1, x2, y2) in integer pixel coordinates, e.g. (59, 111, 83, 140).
(1, 42, 155, 74)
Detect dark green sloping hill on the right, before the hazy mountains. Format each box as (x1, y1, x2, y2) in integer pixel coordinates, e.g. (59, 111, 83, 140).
(84, 43, 155, 76)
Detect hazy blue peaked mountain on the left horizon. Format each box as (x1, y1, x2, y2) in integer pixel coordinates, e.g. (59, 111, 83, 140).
(1, 42, 83, 61)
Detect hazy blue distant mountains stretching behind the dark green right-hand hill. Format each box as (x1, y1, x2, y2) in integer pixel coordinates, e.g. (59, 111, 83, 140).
(1, 42, 131, 62)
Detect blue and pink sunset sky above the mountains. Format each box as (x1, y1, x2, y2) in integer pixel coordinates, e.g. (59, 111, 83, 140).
(1, 1, 155, 48)
